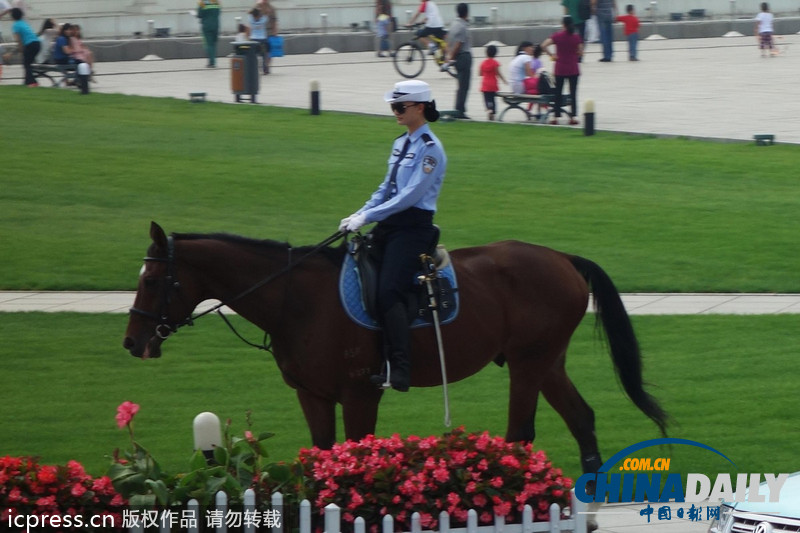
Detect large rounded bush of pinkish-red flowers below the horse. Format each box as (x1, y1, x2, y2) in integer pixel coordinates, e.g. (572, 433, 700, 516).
(274, 428, 572, 531)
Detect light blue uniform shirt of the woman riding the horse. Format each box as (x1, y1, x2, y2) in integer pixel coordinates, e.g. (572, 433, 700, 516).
(358, 124, 447, 223)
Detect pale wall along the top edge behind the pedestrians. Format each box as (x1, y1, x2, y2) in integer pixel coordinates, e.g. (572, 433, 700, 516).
(3, 0, 798, 38)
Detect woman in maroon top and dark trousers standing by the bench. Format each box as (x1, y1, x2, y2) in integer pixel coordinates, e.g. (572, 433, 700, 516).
(542, 17, 583, 125)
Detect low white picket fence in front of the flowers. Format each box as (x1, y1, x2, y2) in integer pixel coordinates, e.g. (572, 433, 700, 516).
(123, 489, 587, 533)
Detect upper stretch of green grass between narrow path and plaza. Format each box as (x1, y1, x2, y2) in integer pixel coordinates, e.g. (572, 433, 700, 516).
(0, 86, 800, 292)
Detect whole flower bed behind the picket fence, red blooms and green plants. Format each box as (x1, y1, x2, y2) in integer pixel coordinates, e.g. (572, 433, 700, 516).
(0, 402, 572, 531)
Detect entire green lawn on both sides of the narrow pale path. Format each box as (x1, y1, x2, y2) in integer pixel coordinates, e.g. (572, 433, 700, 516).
(0, 86, 800, 486)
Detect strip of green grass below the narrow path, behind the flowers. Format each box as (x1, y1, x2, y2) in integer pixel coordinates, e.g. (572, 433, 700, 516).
(0, 313, 800, 477)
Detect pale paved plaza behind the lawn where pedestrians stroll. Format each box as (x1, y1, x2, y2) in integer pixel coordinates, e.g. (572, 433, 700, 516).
(1, 35, 800, 144)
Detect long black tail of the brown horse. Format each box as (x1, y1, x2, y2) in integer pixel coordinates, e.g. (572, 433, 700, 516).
(570, 256, 668, 436)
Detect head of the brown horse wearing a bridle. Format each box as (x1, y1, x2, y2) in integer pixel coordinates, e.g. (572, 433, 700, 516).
(122, 222, 202, 359)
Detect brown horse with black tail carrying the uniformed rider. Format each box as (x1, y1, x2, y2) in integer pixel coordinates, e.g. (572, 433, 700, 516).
(123, 222, 666, 472)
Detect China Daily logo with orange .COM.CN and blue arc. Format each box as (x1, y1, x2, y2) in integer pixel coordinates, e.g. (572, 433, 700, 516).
(575, 438, 789, 520)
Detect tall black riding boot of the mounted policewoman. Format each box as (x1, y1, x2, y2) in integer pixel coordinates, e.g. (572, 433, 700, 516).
(370, 303, 411, 392)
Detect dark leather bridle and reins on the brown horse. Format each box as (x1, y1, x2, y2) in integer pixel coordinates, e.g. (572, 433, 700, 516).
(128, 231, 346, 351)
